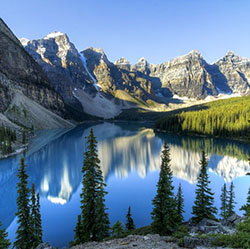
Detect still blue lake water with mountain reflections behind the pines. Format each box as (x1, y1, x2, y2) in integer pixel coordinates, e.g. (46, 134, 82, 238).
(0, 123, 250, 248)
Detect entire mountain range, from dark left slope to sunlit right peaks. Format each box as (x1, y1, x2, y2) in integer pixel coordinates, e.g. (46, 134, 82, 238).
(0, 17, 250, 127)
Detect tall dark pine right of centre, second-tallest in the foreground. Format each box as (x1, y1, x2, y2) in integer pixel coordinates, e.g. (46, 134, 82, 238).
(151, 141, 177, 235)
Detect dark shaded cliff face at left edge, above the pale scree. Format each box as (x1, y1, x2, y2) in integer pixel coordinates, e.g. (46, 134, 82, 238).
(0, 19, 73, 126)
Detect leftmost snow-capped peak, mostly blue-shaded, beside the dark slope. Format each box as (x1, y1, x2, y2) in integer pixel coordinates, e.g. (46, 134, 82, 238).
(22, 32, 96, 111)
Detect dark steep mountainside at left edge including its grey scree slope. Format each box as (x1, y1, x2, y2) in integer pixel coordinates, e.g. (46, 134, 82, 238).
(0, 19, 72, 128)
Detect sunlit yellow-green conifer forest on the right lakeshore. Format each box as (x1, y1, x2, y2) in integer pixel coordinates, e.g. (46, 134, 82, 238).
(155, 96, 250, 137)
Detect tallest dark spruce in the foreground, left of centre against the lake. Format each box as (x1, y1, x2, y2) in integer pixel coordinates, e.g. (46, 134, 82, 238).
(76, 129, 110, 242)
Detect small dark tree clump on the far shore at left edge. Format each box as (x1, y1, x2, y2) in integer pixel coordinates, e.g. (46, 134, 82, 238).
(0, 124, 17, 155)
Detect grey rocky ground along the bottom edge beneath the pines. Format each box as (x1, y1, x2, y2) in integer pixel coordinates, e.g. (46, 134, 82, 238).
(36, 214, 244, 249)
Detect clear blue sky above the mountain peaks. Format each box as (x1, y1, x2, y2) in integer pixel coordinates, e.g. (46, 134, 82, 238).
(0, 0, 250, 63)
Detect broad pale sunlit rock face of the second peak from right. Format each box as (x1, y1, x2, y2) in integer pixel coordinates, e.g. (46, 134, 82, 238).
(149, 51, 218, 98)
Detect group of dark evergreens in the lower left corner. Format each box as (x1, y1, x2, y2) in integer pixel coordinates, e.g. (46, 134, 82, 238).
(0, 158, 43, 249)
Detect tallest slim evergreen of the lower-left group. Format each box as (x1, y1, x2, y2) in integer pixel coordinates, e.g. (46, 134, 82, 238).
(14, 158, 32, 249)
